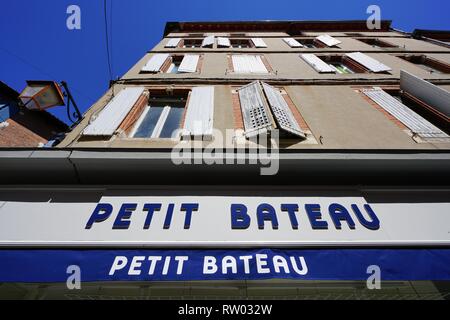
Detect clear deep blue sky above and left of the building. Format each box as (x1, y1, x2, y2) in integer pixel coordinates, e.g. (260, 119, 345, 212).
(0, 0, 450, 121)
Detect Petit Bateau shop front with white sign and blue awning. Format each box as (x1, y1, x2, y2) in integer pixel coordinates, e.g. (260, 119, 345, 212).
(0, 158, 450, 299)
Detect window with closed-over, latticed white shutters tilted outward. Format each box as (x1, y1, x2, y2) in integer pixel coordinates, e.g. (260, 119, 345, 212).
(237, 81, 306, 140)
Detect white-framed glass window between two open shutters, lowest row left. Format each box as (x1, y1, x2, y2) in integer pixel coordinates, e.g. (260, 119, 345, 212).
(131, 97, 186, 138)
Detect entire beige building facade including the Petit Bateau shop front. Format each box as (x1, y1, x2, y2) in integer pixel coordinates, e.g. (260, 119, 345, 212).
(0, 21, 450, 299)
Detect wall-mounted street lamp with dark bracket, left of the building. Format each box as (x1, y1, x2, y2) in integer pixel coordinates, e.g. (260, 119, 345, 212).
(19, 80, 83, 122)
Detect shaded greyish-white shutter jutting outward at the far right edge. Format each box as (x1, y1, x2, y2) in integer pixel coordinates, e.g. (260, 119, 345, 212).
(400, 70, 450, 117)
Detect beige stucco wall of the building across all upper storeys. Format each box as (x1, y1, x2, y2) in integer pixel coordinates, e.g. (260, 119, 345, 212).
(59, 28, 450, 149)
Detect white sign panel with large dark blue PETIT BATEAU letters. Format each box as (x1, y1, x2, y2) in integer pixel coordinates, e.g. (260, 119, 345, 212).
(0, 196, 450, 247)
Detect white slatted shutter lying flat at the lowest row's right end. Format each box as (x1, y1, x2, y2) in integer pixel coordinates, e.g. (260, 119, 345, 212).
(363, 88, 448, 138)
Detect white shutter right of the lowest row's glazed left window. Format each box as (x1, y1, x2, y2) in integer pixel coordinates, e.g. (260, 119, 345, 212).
(183, 86, 214, 137)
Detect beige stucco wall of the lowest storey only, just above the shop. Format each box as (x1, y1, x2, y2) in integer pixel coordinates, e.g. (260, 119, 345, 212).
(60, 85, 450, 149)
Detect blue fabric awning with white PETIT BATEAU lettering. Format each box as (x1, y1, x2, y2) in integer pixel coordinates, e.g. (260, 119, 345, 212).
(0, 249, 450, 282)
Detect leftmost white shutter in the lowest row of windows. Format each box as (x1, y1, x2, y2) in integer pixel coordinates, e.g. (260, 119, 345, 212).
(83, 87, 145, 136)
